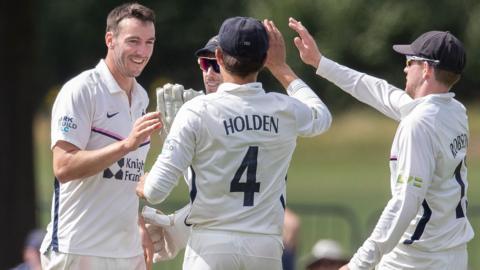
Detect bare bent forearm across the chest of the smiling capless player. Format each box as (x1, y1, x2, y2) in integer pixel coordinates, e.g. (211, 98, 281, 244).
(53, 141, 131, 183)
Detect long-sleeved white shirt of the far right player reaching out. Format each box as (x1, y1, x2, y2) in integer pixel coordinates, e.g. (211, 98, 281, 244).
(317, 57, 473, 270)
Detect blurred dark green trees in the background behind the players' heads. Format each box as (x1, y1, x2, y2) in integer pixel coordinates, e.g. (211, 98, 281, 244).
(36, 0, 480, 114)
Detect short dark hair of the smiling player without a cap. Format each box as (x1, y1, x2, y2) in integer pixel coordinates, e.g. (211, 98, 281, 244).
(106, 3, 155, 34)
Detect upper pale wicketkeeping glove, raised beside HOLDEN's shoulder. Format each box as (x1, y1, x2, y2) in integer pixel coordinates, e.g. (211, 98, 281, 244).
(156, 83, 204, 135)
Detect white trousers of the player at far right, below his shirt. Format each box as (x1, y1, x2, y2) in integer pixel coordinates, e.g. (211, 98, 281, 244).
(375, 244, 468, 270)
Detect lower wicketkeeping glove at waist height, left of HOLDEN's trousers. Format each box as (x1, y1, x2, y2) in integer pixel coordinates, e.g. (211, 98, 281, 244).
(142, 205, 191, 263)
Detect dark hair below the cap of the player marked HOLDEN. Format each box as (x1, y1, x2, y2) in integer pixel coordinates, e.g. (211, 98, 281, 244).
(222, 50, 267, 78)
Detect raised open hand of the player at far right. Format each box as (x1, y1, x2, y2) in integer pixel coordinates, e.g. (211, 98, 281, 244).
(288, 18, 322, 68)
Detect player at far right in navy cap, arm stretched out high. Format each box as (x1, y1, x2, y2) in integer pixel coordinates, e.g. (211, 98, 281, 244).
(289, 19, 473, 270)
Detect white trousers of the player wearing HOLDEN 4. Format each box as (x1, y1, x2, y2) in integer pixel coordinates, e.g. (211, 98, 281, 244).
(183, 228, 283, 270)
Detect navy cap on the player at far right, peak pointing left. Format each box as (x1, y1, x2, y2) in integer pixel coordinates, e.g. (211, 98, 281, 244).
(393, 31, 467, 74)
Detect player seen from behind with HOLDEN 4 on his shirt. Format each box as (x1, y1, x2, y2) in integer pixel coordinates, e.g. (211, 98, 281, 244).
(137, 17, 331, 270)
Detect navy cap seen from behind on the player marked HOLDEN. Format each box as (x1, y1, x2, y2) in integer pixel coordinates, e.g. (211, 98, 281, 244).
(218, 17, 268, 58)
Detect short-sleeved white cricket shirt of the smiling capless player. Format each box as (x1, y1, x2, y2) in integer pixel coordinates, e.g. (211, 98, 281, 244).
(41, 60, 150, 258)
